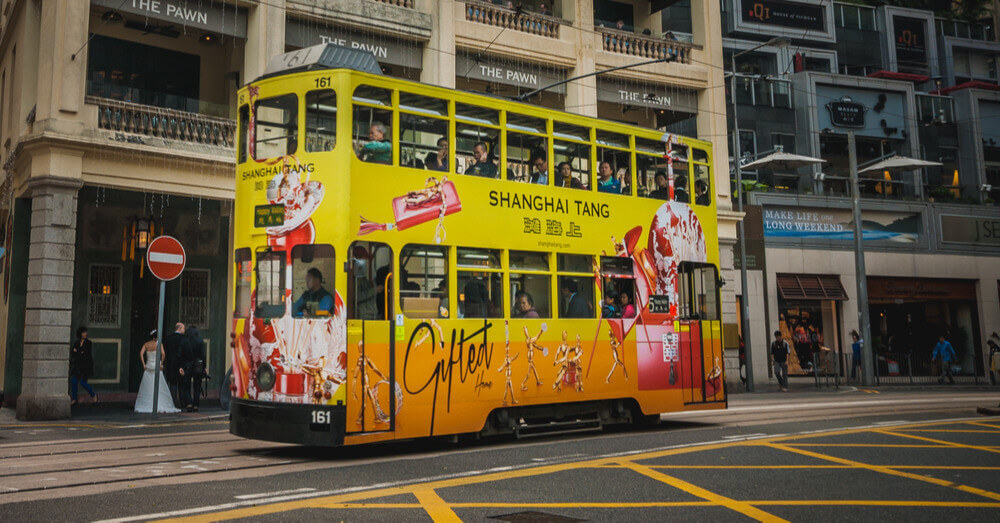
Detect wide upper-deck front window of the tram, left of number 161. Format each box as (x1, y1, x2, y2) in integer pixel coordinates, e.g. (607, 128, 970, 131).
(253, 94, 299, 160)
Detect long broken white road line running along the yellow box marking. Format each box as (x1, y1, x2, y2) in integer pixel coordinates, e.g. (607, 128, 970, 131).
(96, 417, 981, 523)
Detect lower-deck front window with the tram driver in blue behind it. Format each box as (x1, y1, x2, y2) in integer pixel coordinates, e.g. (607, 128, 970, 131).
(292, 244, 336, 318)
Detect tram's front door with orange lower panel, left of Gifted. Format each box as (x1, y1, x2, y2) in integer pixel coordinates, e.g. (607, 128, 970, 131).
(346, 242, 399, 433)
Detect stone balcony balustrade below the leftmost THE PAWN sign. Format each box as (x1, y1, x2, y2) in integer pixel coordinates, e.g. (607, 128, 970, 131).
(87, 96, 236, 148)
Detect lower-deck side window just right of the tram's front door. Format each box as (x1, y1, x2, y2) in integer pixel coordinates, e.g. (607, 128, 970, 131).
(399, 245, 448, 318)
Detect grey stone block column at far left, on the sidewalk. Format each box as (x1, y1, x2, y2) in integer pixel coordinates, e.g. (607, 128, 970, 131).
(17, 176, 83, 420)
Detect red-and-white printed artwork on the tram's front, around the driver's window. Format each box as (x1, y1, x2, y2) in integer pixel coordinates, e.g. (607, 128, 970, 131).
(233, 156, 347, 410)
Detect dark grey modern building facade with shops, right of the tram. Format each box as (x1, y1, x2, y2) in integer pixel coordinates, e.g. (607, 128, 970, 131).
(722, 0, 1000, 384)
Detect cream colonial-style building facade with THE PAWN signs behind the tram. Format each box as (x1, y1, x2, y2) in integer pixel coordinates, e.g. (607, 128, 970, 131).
(0, 0, 738, 419)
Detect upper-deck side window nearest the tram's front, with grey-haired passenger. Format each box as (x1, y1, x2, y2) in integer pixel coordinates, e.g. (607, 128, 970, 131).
(351, 85, 392, 165)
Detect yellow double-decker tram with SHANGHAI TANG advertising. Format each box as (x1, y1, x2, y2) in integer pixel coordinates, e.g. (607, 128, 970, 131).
(230, 45, 726, 445)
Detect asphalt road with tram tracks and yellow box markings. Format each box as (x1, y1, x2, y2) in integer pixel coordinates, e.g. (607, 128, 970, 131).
(0, 391, 1000, 521)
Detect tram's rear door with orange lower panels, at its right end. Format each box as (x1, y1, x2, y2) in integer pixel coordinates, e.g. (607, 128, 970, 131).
(674, 262, 725, 403)
